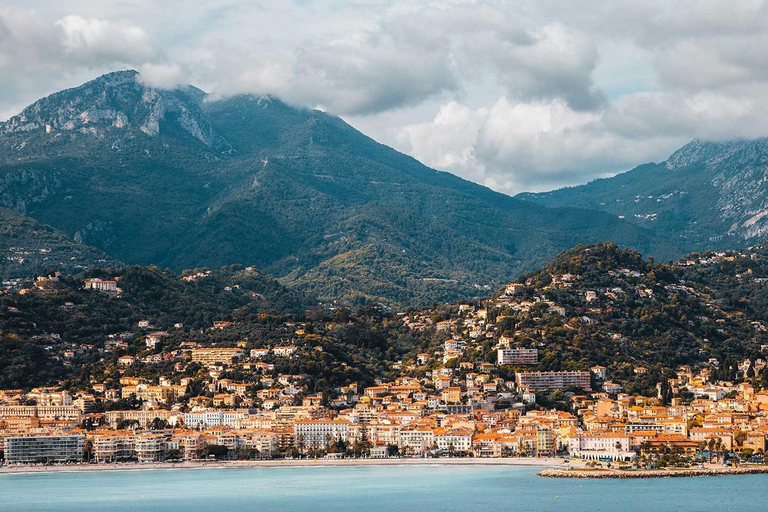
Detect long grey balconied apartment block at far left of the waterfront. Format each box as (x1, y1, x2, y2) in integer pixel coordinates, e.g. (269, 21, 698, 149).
(4, 434, 85, 464)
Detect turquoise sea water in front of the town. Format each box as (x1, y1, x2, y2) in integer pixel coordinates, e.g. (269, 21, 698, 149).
(0, 466, 768, 512)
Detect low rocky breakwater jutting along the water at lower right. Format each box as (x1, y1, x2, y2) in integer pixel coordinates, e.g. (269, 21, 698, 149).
(538, 466, 768, 479)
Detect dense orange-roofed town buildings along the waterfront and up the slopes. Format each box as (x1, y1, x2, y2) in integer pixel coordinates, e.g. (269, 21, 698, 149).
(0, 246, 768, 474)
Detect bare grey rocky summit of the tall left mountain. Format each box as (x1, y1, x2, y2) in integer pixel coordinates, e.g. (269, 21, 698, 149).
(0, 71, 228, 150)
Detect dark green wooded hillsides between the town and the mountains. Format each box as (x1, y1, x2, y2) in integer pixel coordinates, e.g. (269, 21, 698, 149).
(0, 244, 768, 394)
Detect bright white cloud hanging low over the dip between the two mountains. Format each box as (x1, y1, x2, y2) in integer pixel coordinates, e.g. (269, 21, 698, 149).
(399, 97, 689, 194)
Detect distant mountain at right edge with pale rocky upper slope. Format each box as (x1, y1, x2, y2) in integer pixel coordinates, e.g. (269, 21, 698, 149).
(517, 139, 768, 252)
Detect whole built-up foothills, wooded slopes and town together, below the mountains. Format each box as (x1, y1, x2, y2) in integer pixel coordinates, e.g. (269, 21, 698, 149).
(0, 244, 768, 467)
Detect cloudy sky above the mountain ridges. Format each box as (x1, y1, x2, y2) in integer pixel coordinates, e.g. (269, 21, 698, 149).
(0, 0, 768, 194)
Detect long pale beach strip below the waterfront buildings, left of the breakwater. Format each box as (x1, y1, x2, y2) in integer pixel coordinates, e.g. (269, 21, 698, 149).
(0, 457, 562, 476)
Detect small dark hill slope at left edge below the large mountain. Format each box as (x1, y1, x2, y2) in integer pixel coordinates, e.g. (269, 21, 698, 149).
(0, 208, 120, 279)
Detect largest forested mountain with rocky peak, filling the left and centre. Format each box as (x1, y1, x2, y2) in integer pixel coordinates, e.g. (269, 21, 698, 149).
(0, 71, 677, 305)
